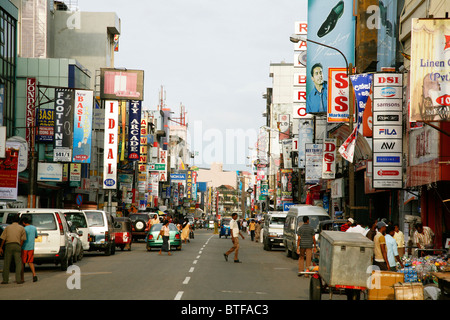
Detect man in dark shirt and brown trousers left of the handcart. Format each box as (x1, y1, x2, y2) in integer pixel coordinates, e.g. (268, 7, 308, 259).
(297, 216, 316, 276)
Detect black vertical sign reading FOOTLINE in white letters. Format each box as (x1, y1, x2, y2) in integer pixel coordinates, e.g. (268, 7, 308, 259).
(53, 88, 74, 162)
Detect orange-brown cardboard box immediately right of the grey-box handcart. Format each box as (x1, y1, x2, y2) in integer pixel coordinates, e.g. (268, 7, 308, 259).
(368, 270, 405, 300)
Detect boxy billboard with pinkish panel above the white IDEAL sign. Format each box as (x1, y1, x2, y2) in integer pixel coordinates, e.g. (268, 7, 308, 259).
(100, 68, 144, 100)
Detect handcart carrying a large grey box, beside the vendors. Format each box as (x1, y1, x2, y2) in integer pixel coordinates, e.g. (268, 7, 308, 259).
(302, 231, 374, 300)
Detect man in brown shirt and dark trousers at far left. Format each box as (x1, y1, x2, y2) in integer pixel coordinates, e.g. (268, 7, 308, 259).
(0, 215, 27, 284)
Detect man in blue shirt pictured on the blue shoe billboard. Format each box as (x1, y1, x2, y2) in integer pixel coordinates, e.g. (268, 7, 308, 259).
(306, 63, 328, 113)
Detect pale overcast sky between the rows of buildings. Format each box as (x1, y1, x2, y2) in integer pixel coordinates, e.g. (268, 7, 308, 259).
(78, 0, 307, 171)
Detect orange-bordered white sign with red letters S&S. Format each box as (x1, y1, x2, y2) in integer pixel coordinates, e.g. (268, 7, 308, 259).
(327, 68, 350, 123)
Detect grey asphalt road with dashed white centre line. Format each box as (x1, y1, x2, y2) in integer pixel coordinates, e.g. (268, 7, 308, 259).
(0, 225, 330, 301)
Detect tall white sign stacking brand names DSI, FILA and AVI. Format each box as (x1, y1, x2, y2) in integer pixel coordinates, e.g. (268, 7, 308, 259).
(372, 73, 403, 189)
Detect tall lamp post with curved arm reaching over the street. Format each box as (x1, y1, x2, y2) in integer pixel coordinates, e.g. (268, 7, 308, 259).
(290, 34, 355, 217)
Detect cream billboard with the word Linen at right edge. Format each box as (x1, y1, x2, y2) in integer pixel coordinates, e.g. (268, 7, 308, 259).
(409, 19, 450, 122)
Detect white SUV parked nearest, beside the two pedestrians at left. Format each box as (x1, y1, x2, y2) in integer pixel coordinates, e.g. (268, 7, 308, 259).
(19, 209, 73, 271)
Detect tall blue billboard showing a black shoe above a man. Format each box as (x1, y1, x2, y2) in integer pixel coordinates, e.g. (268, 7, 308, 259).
(306, 0, 355, 114)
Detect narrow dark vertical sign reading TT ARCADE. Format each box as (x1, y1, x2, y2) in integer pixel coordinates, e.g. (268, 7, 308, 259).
(128, 100, 141, 161)
